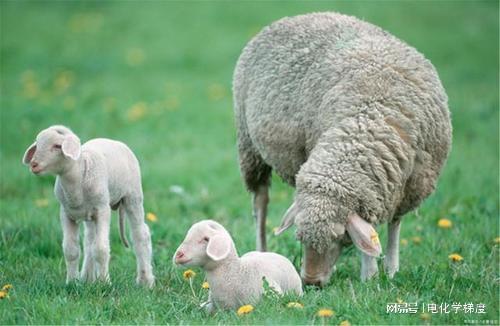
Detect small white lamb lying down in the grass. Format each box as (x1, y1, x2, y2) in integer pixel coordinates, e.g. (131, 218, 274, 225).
(173, 220, 302, 312)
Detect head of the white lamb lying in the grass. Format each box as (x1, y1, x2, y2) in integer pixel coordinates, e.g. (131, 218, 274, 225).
(173, 220, 236, 269)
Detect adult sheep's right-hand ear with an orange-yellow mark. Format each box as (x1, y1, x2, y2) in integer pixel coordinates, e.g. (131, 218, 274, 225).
(346, 213, 382, 257)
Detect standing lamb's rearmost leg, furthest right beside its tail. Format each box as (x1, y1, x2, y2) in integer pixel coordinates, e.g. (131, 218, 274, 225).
(122, 198, 155, 287)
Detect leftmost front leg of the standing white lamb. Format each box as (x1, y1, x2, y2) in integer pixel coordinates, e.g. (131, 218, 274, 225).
(60, 207, 80, 283)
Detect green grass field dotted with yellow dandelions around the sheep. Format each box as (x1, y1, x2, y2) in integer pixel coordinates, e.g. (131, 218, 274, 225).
(0, 1, 500, 324)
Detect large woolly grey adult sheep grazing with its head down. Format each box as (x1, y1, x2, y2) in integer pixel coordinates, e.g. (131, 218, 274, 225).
(233, 13, 452, 285)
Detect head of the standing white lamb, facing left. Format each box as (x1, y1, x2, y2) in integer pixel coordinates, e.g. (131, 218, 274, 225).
(23, 126, 80, 175)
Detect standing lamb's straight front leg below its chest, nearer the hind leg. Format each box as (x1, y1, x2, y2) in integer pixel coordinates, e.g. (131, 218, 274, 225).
(94, 205, 111, 282)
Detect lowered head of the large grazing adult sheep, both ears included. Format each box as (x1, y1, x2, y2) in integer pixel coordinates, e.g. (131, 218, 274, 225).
(275, 196, 382, 286)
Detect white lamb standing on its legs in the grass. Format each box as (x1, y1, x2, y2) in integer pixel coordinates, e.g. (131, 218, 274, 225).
(23, 126, 154, 287)
